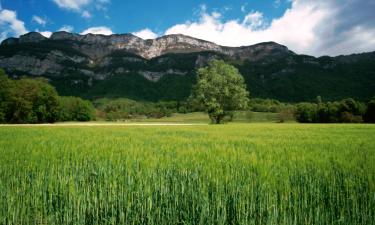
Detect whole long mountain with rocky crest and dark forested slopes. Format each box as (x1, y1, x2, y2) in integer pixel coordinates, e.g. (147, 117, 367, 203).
(0, 32, 375, 102)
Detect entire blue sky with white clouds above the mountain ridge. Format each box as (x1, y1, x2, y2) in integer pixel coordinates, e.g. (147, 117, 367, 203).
(0, 0, 375, 56)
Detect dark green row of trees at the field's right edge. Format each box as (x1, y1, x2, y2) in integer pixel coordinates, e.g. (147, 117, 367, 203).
(294, 97, 375, 123)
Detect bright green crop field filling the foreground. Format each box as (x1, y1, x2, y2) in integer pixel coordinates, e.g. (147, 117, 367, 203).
(0, 123, 375, 225)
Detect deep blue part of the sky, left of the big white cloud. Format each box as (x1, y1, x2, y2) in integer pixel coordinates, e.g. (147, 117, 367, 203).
(1, 0, 290, 33)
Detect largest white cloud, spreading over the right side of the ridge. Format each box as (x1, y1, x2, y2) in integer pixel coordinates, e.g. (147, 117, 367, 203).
(165, 0, 375, 56)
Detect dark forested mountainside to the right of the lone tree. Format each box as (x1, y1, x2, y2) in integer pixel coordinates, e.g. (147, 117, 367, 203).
(238, 52, 375, 103)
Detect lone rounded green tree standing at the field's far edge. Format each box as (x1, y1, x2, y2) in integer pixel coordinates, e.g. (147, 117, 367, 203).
(193, 60, 249, 124)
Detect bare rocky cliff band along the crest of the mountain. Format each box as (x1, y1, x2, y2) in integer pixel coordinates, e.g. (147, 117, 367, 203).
(2, 31, 291, 60)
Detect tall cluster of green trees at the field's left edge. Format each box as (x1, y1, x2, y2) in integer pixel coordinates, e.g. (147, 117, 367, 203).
(0, 69, 95, 123)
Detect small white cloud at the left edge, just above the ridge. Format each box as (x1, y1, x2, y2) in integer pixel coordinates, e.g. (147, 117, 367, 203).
(0, 9, 28, 41)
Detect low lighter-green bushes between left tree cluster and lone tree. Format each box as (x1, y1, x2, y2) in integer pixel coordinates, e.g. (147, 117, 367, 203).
(94, 98, 197, 121)
